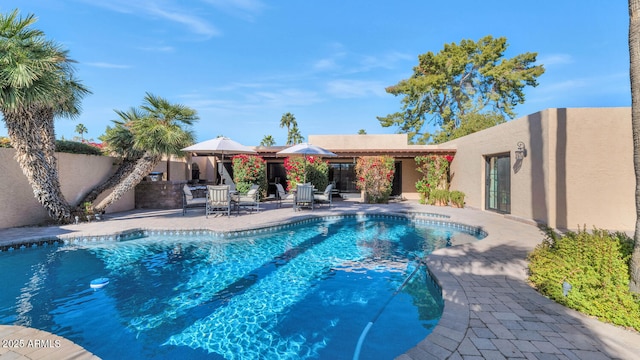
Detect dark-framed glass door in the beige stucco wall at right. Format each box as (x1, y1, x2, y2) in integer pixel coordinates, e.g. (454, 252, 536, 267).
(485, 154, 511, 214)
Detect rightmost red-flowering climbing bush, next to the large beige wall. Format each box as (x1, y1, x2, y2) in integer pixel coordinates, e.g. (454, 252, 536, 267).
(416, 155, 453, 203)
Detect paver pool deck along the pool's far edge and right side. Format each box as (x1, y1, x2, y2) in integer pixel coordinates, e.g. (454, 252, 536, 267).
(0, 201, 640, 360)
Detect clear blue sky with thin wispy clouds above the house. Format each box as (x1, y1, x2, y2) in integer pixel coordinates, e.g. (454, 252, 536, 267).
(0, 0, 631, 145)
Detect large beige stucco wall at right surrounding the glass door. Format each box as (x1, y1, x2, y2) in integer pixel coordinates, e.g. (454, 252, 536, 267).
(440, 108, 635, 230)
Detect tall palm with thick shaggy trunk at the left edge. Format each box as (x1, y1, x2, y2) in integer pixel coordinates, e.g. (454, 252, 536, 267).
(0, 10, 89, 222)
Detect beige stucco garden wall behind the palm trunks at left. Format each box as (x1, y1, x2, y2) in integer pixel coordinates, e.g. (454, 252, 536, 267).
(0, 148, 135, 228)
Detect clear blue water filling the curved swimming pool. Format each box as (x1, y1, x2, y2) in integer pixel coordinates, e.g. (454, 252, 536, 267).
(0, 217, 479, 359)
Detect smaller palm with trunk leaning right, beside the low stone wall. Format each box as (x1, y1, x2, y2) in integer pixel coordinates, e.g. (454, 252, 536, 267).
(83, 93, 198, 212)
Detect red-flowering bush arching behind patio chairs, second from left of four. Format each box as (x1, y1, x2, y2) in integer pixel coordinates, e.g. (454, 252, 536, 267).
(284, 156, 329, 191)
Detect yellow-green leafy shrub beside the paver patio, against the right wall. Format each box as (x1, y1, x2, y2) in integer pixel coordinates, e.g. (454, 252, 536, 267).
(529, 228, 640, 330)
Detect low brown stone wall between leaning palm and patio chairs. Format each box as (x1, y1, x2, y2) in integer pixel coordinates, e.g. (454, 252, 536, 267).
(135, 181, 186, 209)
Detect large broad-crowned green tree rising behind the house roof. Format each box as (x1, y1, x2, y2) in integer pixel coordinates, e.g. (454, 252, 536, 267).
(378, 36, 544, 144)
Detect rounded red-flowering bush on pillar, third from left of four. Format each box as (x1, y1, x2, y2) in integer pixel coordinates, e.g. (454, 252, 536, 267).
(356, 156, 395, 203)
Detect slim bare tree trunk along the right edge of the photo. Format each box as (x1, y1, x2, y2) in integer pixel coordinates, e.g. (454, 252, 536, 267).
(629, 0, 640, 293)
